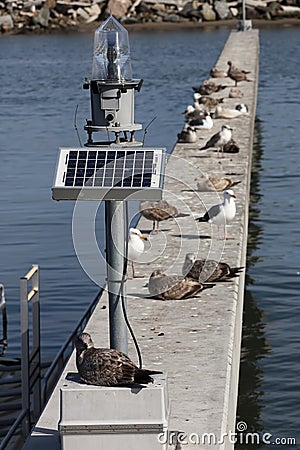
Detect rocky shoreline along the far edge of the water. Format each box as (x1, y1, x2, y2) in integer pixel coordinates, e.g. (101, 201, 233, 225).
(0, 0, 300, 34)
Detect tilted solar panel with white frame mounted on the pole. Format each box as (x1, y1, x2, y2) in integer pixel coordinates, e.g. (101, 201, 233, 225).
(52, 147, 165, 200)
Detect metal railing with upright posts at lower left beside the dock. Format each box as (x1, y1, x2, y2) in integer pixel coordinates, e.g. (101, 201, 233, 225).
(0, 265, 103, 450)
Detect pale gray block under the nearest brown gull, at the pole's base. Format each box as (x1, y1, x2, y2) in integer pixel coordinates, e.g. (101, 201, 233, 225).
(59, 374, 170, 450)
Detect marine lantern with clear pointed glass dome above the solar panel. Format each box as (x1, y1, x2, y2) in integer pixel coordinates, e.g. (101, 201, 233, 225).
(83, 15, 143, 146)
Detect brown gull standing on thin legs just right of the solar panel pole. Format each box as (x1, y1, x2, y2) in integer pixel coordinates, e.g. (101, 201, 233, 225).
(139, 200, 189, 231)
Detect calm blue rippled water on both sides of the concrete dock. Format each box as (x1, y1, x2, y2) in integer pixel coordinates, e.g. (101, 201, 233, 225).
(0, 28, 300, 447)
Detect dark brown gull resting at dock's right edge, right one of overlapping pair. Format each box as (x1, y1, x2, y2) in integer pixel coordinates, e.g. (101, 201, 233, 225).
(182, 253, 243, 283)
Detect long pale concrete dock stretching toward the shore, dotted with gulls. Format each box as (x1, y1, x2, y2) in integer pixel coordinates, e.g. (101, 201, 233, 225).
(23, 30, 259, 450)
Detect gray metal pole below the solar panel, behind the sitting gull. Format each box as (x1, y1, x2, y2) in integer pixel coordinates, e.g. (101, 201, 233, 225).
(105, 200, 128, 354)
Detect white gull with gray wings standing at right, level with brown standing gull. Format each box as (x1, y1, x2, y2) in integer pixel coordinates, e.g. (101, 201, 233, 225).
(196, 189, 236, 239)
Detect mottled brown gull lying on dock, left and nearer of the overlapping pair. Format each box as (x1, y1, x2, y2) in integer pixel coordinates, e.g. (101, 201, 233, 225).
(148, 269, 214, 300)
